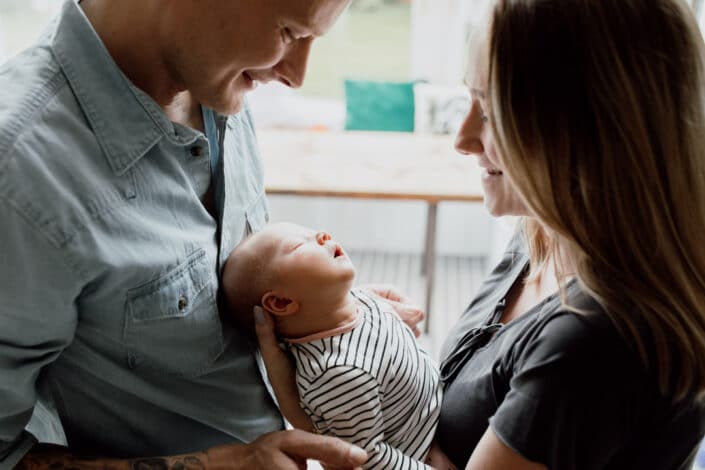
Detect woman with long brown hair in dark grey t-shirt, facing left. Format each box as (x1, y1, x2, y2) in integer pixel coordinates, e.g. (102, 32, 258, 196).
(436, 0, 705, 470)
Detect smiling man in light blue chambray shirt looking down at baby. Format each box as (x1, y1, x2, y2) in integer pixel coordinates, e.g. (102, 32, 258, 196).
(0, 0, 418, 469)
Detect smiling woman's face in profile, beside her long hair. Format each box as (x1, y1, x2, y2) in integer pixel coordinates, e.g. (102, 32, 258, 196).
(455, 41, 529, 217)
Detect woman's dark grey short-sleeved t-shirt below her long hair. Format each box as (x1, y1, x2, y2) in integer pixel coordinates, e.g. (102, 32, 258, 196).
(436, 236, 705, 470)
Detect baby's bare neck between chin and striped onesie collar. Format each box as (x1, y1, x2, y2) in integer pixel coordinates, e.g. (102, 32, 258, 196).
(277, 293, 358, 338)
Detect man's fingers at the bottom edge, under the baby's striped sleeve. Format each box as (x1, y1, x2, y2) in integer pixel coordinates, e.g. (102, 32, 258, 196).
(281, 430, 367, 468)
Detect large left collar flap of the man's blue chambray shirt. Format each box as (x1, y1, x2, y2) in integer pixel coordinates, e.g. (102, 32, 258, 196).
(52, 0, 187, 174)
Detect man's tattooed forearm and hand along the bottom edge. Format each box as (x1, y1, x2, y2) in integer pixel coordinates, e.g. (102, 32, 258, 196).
(15, 430, 367, 470)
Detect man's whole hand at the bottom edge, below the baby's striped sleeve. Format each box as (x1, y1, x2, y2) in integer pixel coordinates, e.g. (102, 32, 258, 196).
(207, 429, 367, 470)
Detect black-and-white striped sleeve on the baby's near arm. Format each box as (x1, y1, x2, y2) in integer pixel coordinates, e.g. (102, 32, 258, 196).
(301, 366, 431, 470)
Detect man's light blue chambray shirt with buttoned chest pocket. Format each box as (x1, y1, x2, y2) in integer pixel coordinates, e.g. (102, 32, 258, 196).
(0, 0, 283, 462)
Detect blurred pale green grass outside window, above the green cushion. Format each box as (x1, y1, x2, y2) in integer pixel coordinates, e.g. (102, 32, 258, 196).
(301, 4, 411, 99)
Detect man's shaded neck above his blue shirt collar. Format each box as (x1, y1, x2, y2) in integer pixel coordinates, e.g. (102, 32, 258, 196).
(80, 0, 197, 129)
